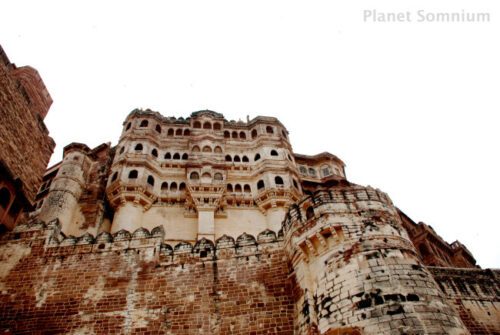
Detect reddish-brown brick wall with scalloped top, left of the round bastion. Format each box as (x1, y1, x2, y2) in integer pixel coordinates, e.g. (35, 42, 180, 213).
(0, 224, 293, 334)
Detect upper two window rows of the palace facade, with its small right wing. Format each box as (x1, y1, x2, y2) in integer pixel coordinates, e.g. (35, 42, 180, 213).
(115, 109, 345, 184)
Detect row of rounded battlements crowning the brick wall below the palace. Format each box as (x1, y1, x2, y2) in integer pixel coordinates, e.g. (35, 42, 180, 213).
(8, 220, 283, 262)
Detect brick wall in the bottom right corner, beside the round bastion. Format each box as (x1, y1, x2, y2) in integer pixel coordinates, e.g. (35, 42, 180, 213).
(429, 267, 500, 334)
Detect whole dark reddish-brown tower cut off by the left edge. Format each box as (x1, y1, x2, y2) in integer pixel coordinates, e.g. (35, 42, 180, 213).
(0, 46, 55, 233)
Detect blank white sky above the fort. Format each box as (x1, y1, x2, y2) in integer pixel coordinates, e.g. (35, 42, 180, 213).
(0, 0, 500, 267)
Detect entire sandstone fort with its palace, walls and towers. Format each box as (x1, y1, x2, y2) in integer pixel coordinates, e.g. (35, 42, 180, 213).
(0, 46, 500, 335)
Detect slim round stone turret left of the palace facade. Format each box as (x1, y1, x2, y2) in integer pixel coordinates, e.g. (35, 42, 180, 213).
(39, 151, 85, 233)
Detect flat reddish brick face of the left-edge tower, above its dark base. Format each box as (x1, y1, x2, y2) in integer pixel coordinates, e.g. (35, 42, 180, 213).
(0, 62, 55, 203)
